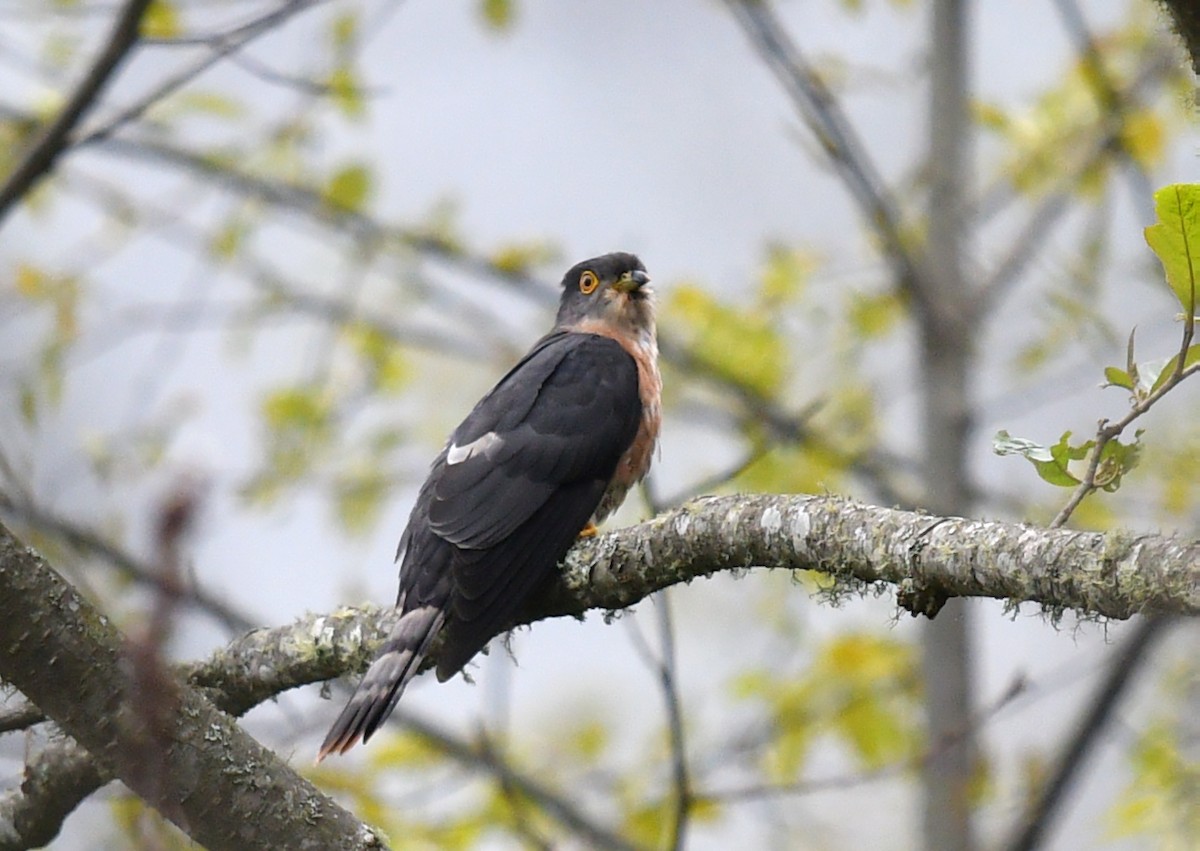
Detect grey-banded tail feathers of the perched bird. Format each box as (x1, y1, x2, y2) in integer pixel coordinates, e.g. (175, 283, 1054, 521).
(317, 606, 445, 762)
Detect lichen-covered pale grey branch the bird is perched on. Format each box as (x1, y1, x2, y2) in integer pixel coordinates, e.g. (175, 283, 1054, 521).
(0, 495, 1200, 847)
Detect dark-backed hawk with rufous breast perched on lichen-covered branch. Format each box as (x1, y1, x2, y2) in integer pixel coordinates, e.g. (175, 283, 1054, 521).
(317, 252, 662, 761)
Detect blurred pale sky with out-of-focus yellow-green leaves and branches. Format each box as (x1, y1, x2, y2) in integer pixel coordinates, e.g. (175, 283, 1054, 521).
(0, 0, 1200, 850)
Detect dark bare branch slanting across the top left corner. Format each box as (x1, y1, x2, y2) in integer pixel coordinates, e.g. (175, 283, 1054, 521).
(0, 0, 150, 224)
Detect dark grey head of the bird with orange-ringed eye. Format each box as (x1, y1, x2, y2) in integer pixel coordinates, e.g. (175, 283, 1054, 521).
(556, 251, 654, 337)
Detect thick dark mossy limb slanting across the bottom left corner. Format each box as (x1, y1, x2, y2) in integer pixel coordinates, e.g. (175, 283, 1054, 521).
(0, 526, 383, 851)
